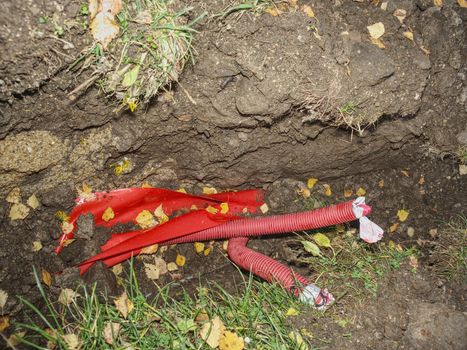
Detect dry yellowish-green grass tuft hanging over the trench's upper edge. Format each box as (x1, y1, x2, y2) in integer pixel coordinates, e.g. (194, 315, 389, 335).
(69, 0, 204, 111)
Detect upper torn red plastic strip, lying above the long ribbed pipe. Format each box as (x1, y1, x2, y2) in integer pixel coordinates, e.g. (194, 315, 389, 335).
(55, 188, 263, 253)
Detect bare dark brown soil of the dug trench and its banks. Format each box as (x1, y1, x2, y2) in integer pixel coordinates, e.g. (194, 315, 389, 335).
(0, 0, 467, 349)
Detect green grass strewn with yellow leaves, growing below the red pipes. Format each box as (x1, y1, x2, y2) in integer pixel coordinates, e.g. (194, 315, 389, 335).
(17, 269, 310, 349)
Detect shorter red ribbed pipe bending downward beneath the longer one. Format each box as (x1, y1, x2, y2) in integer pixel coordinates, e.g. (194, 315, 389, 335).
(228, 237, 310, 297)
